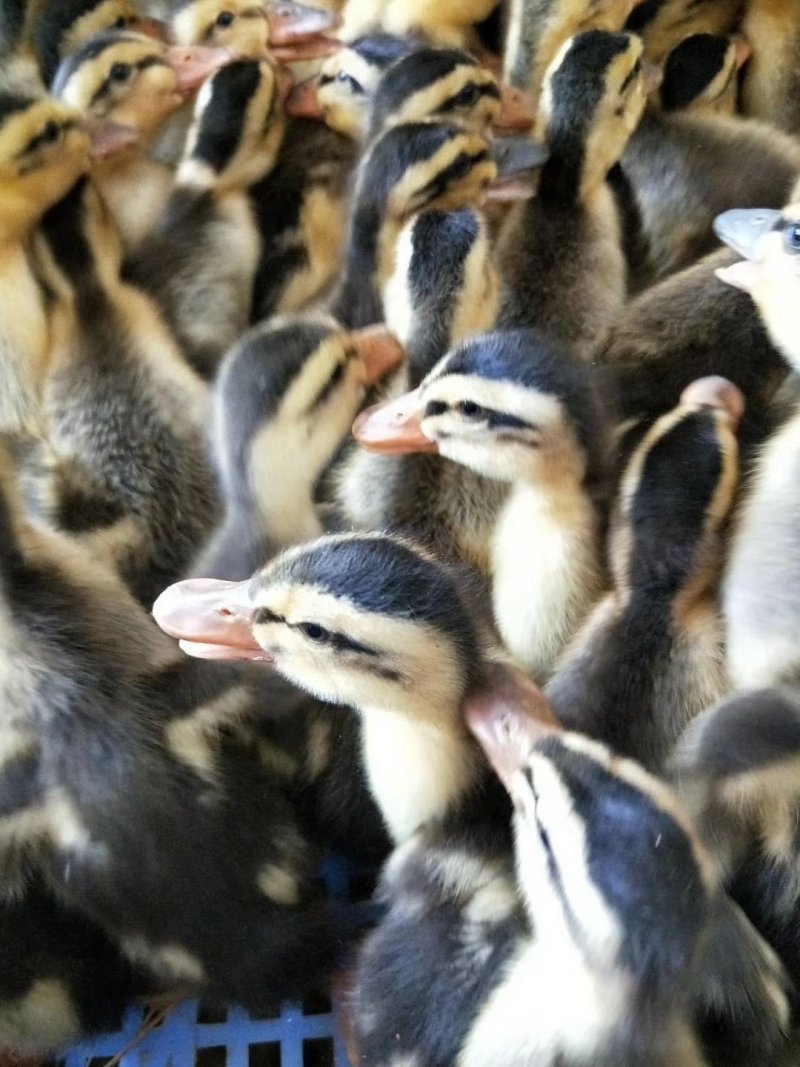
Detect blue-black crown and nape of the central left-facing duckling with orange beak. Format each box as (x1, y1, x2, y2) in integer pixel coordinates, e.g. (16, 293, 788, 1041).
(443, 330, 604, 481)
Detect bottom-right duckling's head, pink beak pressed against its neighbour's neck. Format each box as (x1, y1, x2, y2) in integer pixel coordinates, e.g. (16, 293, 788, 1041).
(468, 706, 716, 997)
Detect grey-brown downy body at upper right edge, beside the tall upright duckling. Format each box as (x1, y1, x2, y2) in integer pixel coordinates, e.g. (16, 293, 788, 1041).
(622, 64, 800, 289)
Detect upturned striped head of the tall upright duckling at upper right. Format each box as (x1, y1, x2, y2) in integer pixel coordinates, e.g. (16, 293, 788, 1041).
(535, 30, 647, 199)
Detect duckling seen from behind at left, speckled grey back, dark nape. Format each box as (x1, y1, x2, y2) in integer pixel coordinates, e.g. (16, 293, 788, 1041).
(31, 163, 217, 604)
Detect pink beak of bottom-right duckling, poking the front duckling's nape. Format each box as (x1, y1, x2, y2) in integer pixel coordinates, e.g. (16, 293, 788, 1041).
(464, 664, 561, 792)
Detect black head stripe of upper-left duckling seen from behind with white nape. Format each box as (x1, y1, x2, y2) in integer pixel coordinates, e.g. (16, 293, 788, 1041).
(192, 60, 261, 174)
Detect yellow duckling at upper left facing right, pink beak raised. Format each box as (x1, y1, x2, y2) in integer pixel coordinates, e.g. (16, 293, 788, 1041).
(52, 31, 230, 251)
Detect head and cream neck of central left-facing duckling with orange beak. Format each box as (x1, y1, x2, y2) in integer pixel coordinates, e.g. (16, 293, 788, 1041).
(353, 331, 606, 680)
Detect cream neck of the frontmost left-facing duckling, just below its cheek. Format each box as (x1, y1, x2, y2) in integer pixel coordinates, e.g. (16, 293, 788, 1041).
(362, 707, 481, 844)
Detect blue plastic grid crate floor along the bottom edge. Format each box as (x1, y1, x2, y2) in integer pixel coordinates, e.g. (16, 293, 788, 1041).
(61, 1001, 349, 1067)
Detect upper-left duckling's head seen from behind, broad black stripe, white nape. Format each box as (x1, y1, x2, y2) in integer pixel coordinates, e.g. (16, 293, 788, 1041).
(178, 60, 288, 191)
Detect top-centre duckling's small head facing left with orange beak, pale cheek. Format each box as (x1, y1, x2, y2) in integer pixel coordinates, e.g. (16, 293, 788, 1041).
(286, 33, 414, 141)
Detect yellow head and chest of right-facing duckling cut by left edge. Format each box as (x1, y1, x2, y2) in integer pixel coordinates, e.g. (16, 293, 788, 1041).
(0, 95, 91, 435)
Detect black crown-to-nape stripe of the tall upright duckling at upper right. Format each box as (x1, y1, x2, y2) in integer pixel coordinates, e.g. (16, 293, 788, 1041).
(543, 30, 630, 197)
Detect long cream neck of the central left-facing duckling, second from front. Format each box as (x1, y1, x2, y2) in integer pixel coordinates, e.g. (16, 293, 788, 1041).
(492, 482, 603, 682)
